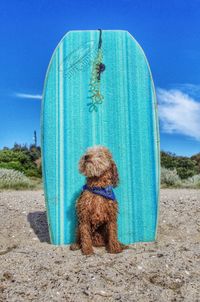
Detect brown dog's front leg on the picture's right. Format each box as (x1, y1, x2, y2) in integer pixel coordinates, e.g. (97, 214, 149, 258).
(107, 221, 123, 254)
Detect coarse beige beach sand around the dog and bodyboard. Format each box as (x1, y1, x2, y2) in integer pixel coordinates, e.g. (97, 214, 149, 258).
(0, 189, 200, 302)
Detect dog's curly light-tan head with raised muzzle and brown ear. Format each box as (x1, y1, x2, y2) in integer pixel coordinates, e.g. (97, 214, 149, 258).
(79, 146, 119, 187)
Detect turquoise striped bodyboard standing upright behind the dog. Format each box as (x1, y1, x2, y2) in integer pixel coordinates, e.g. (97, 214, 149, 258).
(41, 30, 160, 245)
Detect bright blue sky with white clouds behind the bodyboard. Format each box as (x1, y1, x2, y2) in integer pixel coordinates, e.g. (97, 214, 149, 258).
(0, 0, 200, 156)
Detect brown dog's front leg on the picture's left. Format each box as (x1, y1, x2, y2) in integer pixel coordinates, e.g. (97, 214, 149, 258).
(79, 223, 94, 255)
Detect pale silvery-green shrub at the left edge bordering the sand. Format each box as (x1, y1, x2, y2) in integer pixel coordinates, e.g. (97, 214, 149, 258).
(0, 169, 32, 189)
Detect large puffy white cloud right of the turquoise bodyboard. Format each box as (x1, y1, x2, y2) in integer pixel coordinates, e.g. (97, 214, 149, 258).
(157, 88, 200, 141)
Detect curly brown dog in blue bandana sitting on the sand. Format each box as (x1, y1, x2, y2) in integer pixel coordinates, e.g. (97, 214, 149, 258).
(70, 146, 128, 255)
